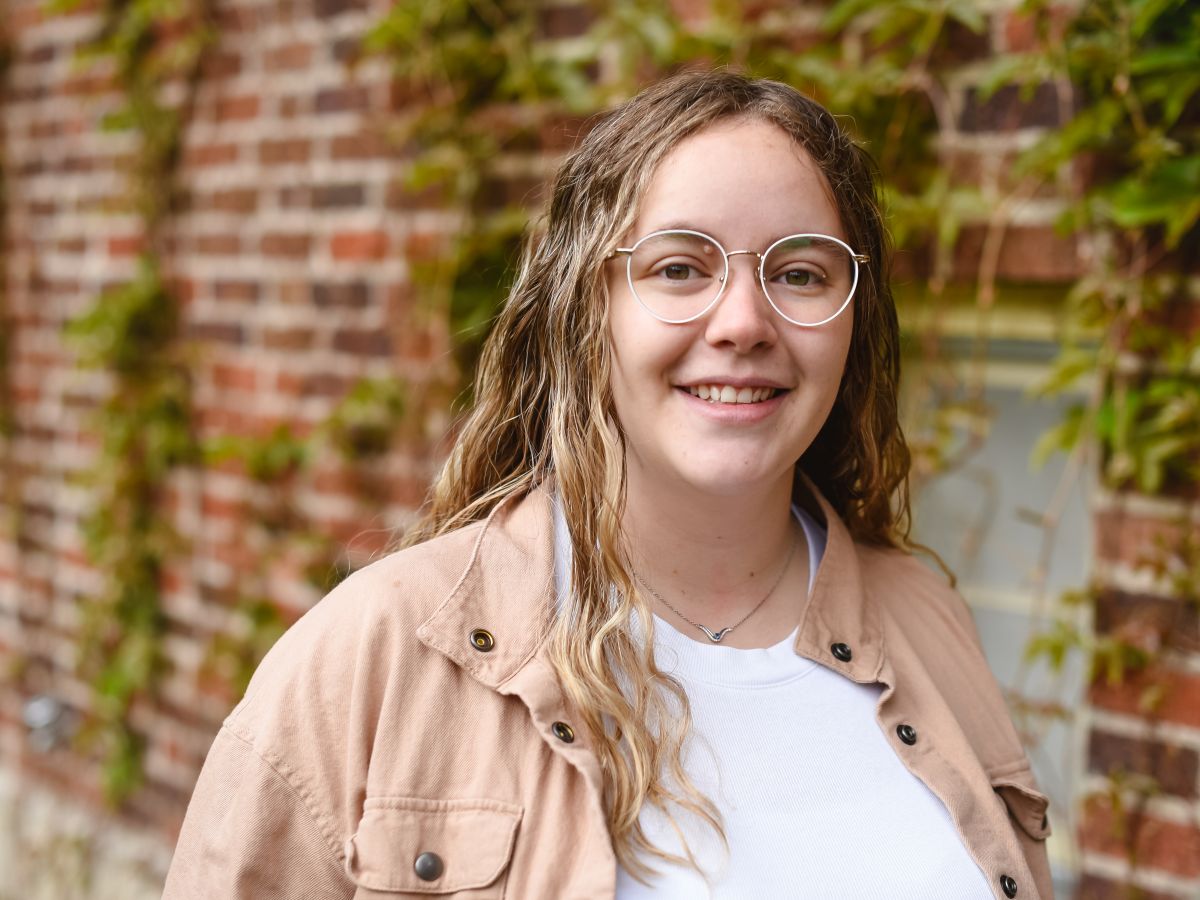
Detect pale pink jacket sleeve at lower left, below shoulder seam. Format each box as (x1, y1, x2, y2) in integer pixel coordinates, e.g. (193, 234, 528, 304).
(163, 726, 354, 900)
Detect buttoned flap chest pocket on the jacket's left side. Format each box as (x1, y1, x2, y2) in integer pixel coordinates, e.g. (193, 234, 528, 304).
(346, 797, 521, 900)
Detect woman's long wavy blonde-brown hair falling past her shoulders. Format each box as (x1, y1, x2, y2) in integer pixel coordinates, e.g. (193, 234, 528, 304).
(404, 71, 912, 880)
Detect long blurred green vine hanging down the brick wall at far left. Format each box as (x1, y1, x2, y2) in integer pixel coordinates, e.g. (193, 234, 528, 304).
(55, 0, 212, 802)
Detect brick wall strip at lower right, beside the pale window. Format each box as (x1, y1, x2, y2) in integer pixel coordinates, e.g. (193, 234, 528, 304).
(1080, 489, 1200, 900)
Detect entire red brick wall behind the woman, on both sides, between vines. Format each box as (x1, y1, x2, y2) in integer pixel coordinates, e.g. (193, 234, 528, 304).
(0, 0, 1200, 898)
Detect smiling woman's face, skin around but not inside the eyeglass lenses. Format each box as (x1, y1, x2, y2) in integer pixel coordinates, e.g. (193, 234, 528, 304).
(606, 119, 853, 497)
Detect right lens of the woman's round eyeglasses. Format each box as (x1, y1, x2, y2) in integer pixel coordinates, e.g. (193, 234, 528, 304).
(762, 234, 857, 325)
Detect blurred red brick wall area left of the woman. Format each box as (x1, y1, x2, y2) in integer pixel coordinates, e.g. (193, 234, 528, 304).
(0, 0, 456, 854)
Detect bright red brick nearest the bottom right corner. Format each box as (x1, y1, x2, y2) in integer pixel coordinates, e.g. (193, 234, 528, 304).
(1080, 796, 1200, 878)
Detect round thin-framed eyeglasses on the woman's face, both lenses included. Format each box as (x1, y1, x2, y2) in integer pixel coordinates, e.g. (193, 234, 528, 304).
(606, 229, 870, 328)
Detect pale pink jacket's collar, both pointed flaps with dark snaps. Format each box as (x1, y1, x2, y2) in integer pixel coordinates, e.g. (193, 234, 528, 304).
(416, 473, 883, 689)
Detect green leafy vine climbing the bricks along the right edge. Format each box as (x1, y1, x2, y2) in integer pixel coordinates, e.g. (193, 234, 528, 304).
(1010, 0, 1200, 888)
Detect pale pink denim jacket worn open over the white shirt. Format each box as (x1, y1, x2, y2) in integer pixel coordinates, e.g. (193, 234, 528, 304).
(163, 487, 1052, 900)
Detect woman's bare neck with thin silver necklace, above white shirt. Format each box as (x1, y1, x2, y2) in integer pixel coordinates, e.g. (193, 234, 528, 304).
(623, 467, 809, 647)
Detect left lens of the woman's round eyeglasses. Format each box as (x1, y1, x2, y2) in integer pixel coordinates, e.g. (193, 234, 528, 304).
(629, 232, 725, 322)
